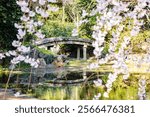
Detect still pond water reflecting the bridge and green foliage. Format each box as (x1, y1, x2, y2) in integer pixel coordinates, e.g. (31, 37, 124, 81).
(0, 71, 150, 100)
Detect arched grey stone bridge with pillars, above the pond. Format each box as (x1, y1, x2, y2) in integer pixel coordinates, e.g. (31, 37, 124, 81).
(36, 37, 92, 60)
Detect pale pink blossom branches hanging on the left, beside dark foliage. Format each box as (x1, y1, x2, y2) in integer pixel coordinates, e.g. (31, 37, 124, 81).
(0, 0, 58, 68)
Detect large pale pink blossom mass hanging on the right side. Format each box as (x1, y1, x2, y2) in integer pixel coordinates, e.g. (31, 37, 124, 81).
(78, 0, 150, 97)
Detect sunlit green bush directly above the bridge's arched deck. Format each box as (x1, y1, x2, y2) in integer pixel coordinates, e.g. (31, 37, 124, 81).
(42, 20, 74, 37)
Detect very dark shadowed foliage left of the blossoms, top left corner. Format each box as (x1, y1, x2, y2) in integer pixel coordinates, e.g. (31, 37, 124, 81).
(0, 0, 21, 51)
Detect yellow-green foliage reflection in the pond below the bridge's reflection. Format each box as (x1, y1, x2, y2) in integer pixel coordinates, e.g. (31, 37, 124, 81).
(34, 84, 98, 100)
